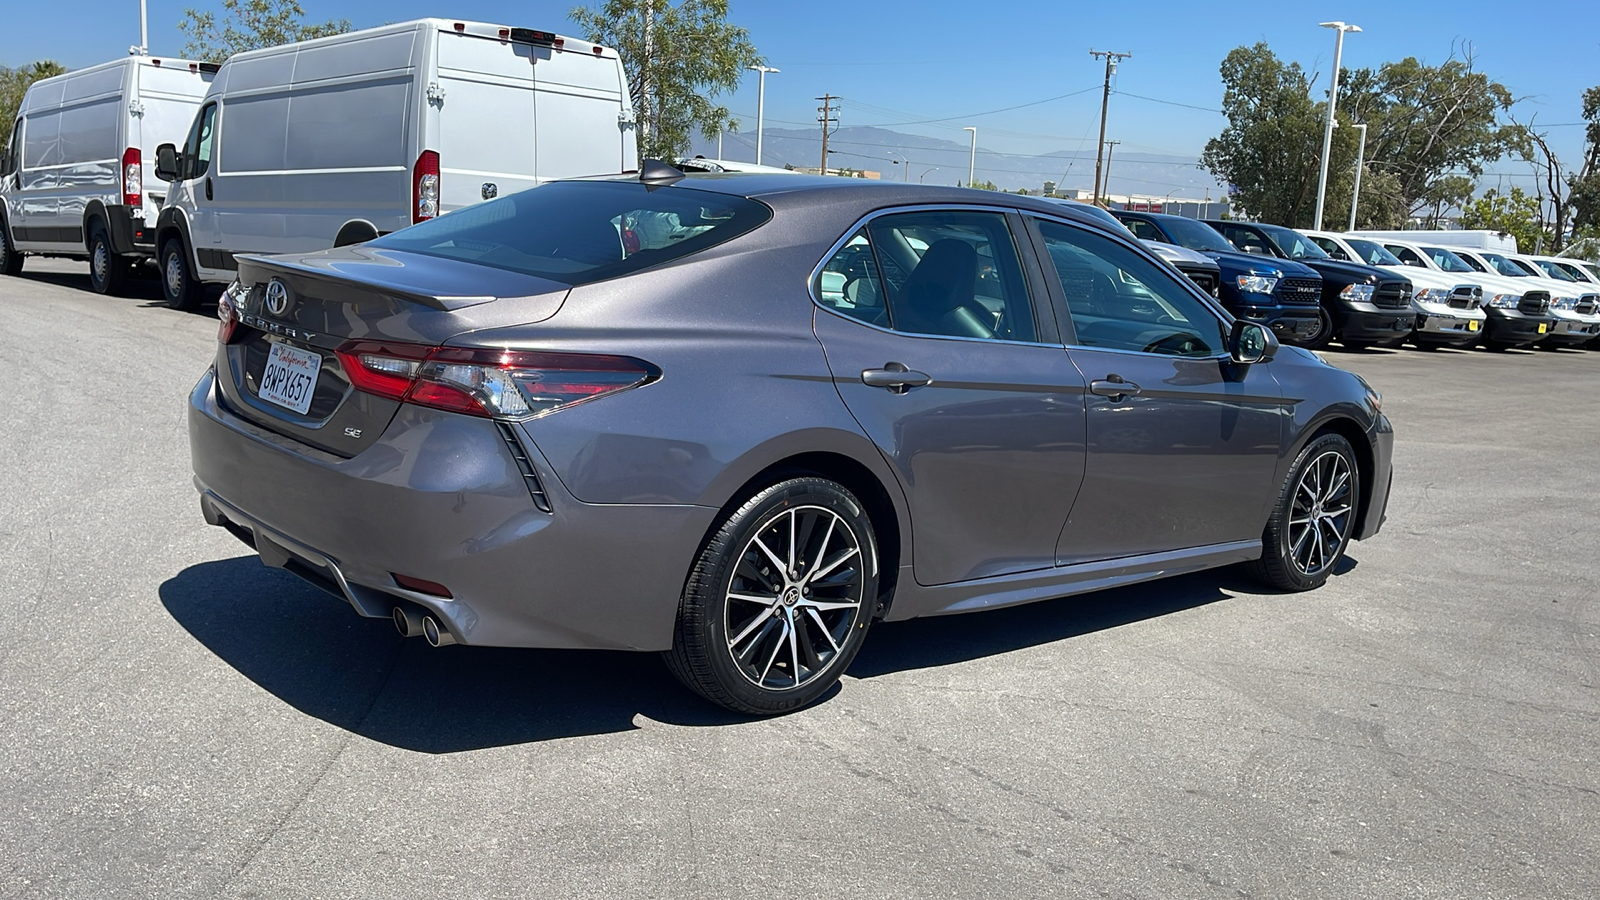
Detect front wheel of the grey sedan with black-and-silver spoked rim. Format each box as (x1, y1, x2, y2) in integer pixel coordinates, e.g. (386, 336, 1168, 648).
(1250, 434, 1362, 591)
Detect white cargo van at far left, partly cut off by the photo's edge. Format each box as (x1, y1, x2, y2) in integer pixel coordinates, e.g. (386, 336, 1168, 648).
(0, 56, 218, 293)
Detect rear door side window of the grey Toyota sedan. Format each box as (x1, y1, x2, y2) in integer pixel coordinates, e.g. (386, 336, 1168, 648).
(814, 210, 1038, 341)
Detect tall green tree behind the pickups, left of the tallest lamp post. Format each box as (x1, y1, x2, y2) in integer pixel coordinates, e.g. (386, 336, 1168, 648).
(1200, 43, 1365, 227)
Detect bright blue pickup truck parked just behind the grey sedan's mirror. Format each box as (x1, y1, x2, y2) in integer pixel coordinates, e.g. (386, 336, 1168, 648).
(1112, 210, 1322, 346)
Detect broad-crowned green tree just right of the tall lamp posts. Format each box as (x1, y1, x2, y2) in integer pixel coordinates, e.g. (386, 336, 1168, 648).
(1339, 53, 1528, 221)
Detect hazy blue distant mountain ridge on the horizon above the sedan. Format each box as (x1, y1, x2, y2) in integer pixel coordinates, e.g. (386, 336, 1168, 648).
(693, 127, 1227, 199)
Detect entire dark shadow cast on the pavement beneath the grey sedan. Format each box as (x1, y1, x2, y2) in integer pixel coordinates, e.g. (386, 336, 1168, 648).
(160, 556, 1355, 753)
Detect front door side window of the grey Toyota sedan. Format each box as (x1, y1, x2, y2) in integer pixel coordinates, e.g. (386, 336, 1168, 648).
(1038, 221, 1226, 357)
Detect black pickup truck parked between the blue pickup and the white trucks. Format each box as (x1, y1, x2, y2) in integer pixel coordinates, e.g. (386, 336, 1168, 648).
(1206, 219, 1416, 349)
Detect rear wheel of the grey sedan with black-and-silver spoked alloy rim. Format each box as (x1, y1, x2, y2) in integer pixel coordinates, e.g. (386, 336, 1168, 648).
(664, 477, 878, 716)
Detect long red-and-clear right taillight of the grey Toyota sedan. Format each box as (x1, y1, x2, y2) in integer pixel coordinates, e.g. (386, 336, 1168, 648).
(338, 341, 659, 420)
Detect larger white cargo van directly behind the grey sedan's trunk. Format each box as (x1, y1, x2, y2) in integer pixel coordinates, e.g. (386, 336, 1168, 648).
(157, 19, 638, 307)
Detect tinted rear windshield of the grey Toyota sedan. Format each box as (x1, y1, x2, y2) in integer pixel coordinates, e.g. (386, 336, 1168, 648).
(366, 181, 771, 285)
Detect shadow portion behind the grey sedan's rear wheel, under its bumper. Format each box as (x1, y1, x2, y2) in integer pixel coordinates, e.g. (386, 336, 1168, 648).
(160, 556, 749, 753)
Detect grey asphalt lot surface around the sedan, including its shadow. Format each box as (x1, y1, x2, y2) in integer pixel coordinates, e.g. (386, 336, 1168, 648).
(0, 261, 1600, 898)
